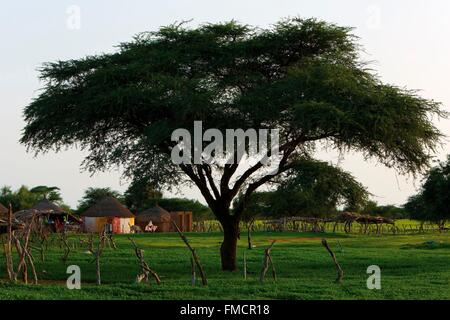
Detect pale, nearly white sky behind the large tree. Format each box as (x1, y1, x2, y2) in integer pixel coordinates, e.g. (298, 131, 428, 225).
(0, 0, 450, 206)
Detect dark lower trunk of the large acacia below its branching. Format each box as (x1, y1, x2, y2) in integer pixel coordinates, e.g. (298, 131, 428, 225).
(220, 216, 239, 271)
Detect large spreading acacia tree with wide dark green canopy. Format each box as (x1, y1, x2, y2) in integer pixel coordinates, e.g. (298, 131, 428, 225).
(22, 18, 442, 270)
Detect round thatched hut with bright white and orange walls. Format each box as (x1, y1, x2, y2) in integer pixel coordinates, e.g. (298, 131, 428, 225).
(81, 197, 134, 234)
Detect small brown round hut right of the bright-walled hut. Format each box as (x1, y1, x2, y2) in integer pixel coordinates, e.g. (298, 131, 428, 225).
(136, 206, 173, 232)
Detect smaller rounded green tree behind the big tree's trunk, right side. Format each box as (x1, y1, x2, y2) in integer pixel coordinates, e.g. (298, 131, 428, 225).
(235, 159, 369, 219)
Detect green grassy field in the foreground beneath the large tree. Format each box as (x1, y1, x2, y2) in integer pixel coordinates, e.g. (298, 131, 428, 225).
(0, 232, 450, 300)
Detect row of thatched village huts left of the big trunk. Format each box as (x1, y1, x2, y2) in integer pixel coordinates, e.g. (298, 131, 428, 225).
(0, 197, 193, 234)
